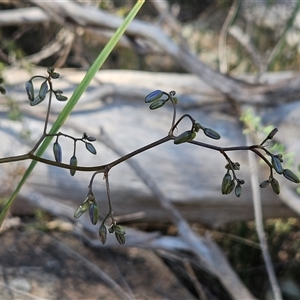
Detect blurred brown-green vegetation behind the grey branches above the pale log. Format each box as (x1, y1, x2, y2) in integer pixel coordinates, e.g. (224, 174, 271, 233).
(0, 0, 300, 75)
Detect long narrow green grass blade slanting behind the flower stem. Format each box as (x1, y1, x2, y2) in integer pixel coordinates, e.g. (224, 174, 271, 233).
(0, 0, 145, 227)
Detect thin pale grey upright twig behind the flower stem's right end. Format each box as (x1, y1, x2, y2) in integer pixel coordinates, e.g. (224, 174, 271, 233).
(246, 135, 282, 300)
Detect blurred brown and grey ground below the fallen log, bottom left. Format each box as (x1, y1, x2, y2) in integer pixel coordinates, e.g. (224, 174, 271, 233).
(0, 226, 194, 300)
